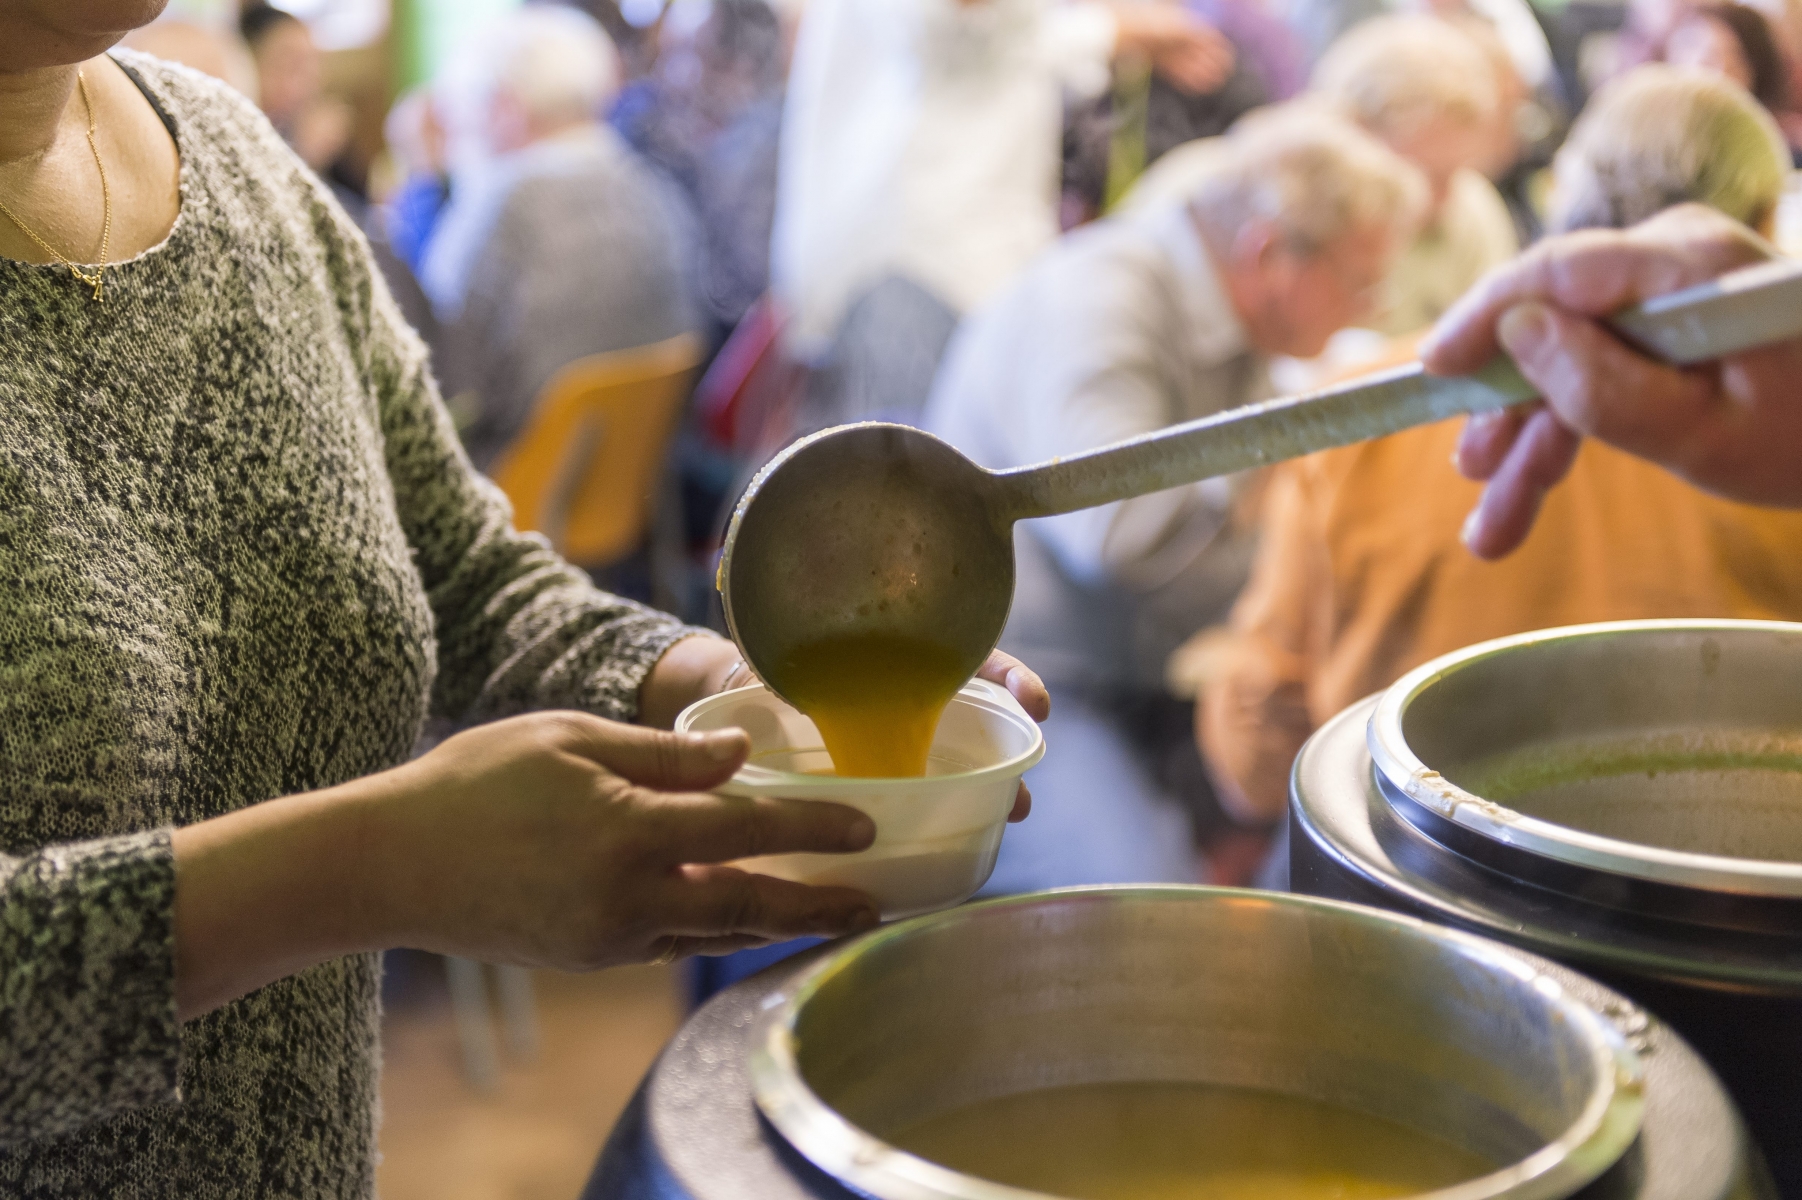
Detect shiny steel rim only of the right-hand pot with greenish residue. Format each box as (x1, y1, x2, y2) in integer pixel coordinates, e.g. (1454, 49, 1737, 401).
(1366, 618, 1802, 899)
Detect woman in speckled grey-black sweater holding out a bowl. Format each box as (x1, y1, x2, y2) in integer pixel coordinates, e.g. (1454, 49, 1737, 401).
(0, 0, 1045, 1200)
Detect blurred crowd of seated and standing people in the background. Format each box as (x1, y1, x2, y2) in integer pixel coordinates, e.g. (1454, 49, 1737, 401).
(133, 0, 1802, 969)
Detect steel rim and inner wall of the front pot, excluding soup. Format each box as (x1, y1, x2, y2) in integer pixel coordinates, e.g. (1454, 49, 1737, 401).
(748, 888, 1642, 1200)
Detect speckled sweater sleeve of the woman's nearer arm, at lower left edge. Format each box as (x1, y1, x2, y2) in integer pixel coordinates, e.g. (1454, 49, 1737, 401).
(0, 829, 180, 1146)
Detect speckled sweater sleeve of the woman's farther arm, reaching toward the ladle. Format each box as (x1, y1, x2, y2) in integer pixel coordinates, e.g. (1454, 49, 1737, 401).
(353, 211, 714, 721)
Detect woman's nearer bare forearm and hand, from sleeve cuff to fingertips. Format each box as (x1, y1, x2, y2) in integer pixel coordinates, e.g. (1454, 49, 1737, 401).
(175, 712, 878, 1020)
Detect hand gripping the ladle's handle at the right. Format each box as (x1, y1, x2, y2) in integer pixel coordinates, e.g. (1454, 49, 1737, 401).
(1422, 205, 1802, 559)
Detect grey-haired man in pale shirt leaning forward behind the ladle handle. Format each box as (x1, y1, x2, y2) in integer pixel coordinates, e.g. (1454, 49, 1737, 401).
(926, 106, 1425, 892)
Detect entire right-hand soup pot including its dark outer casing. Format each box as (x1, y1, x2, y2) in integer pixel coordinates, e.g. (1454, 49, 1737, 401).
(1292, 622, 1802, 1196)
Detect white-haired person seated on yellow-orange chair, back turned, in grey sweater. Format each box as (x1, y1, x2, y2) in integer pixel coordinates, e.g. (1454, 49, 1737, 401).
(420, 5, 699, 470)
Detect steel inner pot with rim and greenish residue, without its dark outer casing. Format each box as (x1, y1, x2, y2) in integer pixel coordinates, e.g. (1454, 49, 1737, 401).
(1370, 620, 1802, 915)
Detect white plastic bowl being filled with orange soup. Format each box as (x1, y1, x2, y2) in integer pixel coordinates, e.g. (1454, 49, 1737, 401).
(676, 679, 1045, 921)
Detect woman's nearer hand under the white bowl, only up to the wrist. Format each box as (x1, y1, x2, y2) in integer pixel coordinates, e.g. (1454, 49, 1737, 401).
(368, 712, 876, 971)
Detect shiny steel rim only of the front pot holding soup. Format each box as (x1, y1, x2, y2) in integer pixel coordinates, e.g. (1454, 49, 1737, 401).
(746, 885, 1645, 1200)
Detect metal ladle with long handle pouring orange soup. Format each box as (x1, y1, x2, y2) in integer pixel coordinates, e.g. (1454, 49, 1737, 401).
(719, 252, 1802, 699)
